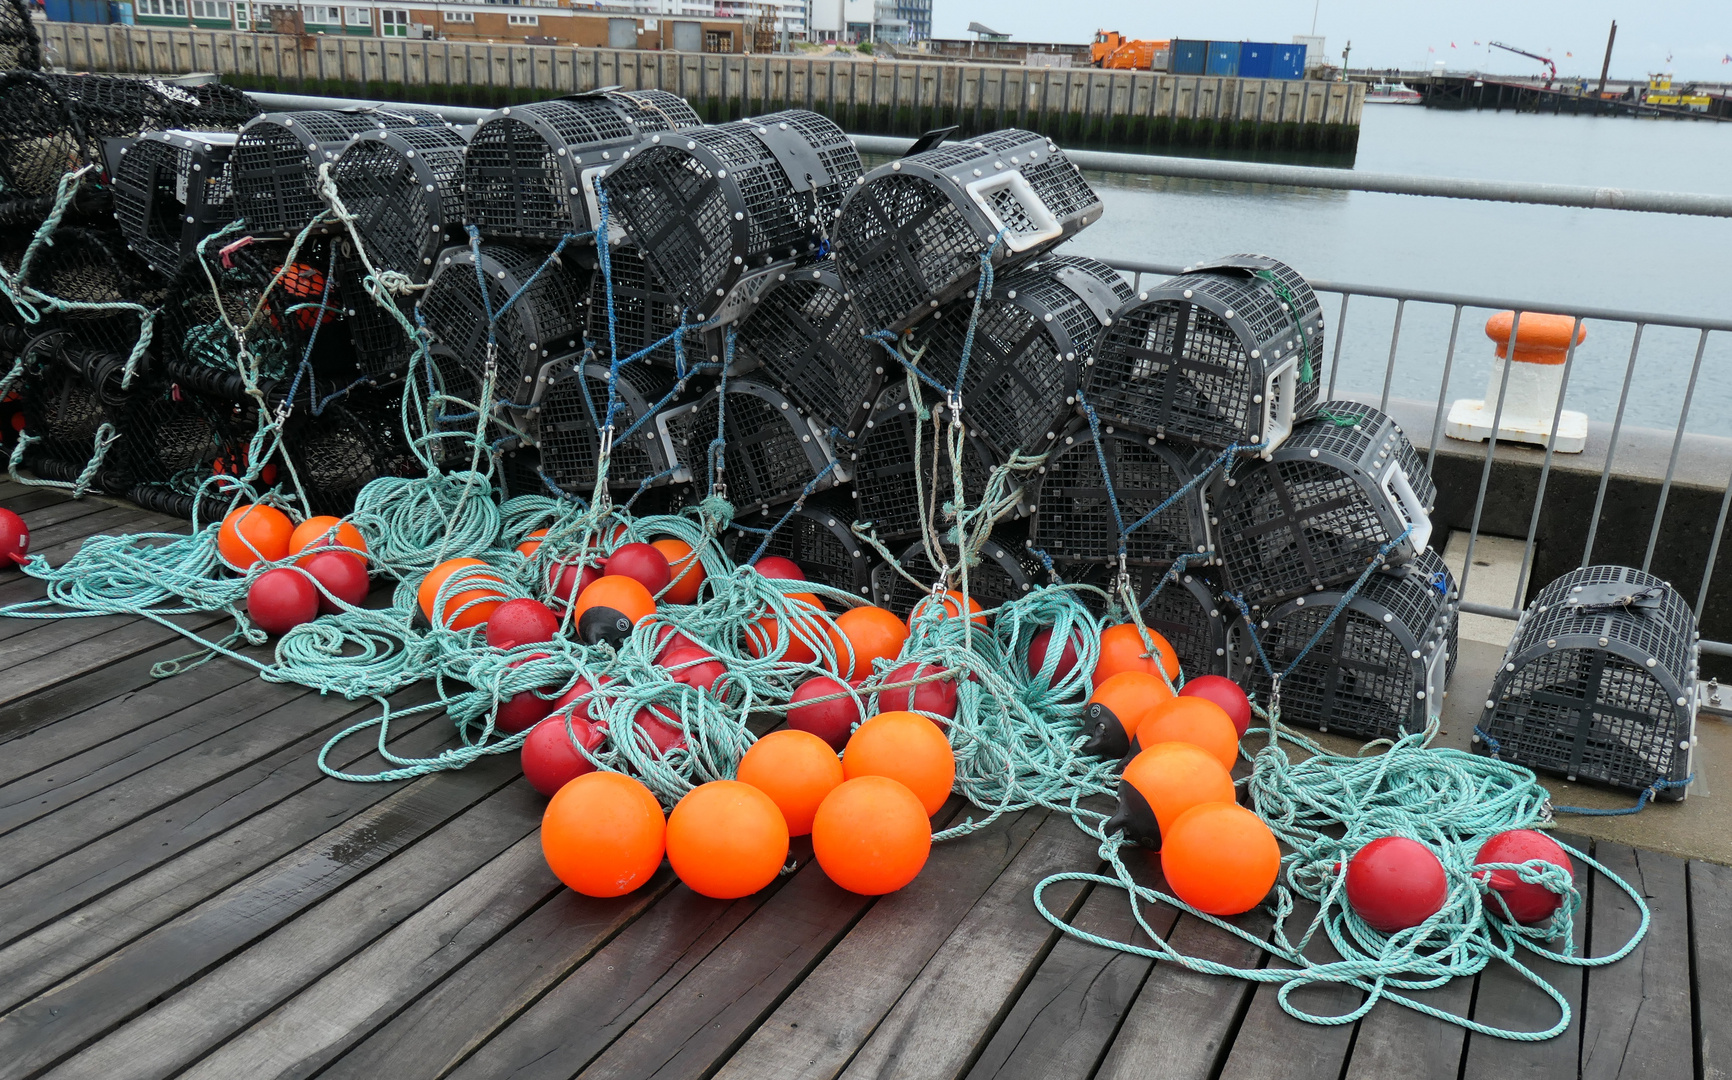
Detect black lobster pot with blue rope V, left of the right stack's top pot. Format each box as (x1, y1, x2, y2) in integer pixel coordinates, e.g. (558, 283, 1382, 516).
(1029, 421, 1214, 566)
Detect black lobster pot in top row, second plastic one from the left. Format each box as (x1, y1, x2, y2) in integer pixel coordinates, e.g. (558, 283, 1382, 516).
(230, 109, 433, 237)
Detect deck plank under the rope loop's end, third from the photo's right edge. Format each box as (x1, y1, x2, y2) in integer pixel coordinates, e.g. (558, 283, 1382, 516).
(1462, 833, 1593, 1080)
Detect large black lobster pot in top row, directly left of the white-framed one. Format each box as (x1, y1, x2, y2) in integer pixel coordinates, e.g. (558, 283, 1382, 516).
(606, 109, 861, 320)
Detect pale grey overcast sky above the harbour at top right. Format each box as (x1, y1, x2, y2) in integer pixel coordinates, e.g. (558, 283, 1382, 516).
(932, 0, 1732, 81)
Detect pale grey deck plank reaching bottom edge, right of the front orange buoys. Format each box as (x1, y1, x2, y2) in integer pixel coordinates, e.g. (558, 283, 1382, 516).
(842, 813, 1100, 1078)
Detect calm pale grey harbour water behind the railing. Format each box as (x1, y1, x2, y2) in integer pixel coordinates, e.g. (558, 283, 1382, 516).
(1074, 106, 1732, 436)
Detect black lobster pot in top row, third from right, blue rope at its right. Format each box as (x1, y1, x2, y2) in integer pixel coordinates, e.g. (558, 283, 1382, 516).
(462, 88, 703, 241)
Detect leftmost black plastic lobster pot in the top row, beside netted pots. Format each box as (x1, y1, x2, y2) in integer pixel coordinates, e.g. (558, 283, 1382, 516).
(106, 132, 237, 273)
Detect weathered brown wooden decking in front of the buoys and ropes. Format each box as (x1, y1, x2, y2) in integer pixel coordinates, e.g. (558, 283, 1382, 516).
(0, 483, 1711, 1080)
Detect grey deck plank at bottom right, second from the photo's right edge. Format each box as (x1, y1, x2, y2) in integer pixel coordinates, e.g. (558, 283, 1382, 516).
(1581, 841, 1696, 1080)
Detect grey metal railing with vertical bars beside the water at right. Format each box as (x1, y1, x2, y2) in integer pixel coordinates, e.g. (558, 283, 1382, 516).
(1102, 258, 1732, 656)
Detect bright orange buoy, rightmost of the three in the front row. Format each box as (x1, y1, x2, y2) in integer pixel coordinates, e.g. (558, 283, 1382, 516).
(812, 775, 932, 897)
